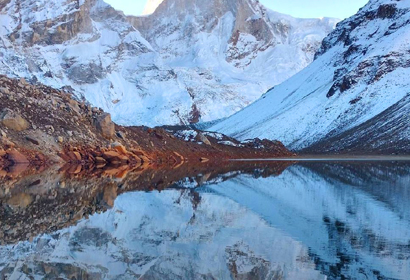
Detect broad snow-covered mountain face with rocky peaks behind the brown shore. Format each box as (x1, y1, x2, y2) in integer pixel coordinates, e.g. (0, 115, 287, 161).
(0, 0, 336, 126)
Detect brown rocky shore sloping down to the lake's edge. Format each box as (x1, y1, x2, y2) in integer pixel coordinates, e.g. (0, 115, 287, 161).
(0, 76, 293, 177)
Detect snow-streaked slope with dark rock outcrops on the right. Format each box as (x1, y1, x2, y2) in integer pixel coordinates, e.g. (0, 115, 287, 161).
(211, 0, 410, 152)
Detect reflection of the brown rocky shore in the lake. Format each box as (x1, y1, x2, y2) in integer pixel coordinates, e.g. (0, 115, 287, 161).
(0, 163, 288, 246)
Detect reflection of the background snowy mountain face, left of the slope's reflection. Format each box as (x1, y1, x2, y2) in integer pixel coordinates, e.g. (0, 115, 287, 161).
(0, 191, 324, 279)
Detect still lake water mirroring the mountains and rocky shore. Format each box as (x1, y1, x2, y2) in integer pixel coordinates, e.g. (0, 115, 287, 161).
(0, 162, 410, 280)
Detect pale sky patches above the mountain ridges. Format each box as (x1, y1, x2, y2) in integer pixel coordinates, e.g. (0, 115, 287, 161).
(104, 0, 368, 19)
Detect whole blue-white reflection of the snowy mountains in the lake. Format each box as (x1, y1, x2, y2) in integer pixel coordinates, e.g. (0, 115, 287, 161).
(0, 165, 410, 279)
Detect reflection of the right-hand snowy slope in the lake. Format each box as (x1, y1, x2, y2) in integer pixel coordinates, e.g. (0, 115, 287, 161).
(206, 167, 410, 279)
